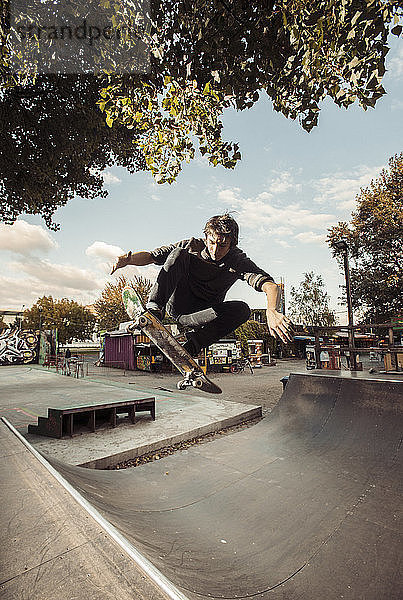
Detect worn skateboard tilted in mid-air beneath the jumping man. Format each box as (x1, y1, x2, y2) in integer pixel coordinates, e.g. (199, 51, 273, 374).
(122, 287, 222, 394)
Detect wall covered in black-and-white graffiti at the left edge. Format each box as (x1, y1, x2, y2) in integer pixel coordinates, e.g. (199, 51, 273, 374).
(0, 327, 39, 366)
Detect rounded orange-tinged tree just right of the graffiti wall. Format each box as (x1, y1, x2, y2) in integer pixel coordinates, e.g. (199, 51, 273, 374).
(22, 296, 95, 344)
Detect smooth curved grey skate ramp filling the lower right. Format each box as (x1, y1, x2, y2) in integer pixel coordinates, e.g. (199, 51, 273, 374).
(1, 375, 403, 600)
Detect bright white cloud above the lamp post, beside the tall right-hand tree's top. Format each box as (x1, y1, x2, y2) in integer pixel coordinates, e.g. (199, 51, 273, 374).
(312, 165, 383, 211)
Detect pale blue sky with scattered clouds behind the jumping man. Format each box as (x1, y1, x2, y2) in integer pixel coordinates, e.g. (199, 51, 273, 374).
(0, 37, 403, 324)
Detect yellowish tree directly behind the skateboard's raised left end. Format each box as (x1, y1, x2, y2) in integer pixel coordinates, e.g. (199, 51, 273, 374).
(94, 275, 152, 331)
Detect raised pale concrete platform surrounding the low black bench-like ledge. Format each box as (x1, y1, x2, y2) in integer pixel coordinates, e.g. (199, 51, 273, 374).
(0, 366, 274, 468)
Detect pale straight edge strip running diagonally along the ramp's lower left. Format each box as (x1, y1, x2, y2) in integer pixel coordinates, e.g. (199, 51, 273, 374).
(1, 417, 189, 600)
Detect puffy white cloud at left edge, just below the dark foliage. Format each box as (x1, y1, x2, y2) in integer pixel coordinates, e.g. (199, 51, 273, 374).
(0, 219, 57, 256)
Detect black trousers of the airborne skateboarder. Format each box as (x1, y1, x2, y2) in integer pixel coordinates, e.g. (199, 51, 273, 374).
(147, 248, 250, 355)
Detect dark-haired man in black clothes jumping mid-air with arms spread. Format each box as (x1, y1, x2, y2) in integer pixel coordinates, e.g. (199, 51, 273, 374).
(111, 214, 292, 356)
